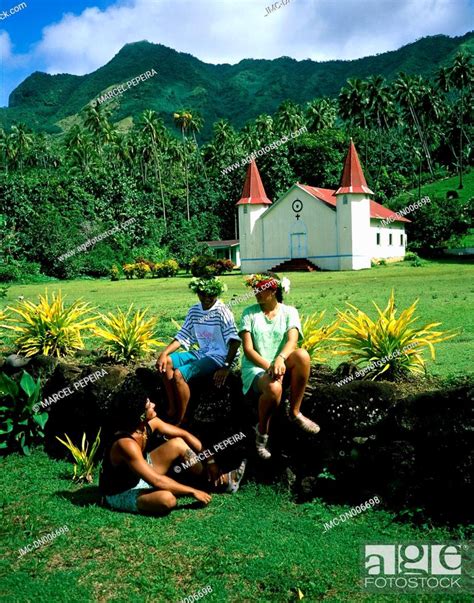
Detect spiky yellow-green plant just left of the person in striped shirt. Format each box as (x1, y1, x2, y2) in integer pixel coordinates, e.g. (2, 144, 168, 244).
(94, 304, 166, 362)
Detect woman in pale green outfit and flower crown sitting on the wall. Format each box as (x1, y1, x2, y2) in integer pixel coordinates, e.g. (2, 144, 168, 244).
(240, 272, 320, 459)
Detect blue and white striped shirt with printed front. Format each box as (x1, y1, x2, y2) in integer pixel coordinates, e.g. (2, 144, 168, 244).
(175, 299, 240, 364)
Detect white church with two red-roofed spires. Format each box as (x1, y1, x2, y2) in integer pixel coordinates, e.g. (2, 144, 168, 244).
(208, 140, 409, 274)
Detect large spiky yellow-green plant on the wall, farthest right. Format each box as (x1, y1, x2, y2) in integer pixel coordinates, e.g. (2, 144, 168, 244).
(335, 291, 458, 379)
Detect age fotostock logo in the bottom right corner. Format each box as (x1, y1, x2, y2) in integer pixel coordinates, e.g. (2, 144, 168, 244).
(362, 541, 474, 593)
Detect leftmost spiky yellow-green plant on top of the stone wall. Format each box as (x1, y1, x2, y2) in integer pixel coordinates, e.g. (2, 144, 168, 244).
(4, 291, 96, 357)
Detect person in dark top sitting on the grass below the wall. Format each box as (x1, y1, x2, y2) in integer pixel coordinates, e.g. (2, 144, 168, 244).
(99, 382, 243, 515)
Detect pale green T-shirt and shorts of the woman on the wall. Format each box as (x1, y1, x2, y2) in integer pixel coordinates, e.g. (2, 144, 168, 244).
(240, 304, 302, 394)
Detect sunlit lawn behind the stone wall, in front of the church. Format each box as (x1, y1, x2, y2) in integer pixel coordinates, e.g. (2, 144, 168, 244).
(3, 260, 474, 377)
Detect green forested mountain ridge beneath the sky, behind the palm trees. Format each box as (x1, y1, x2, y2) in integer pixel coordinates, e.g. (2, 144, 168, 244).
(0, 32, 474, 138)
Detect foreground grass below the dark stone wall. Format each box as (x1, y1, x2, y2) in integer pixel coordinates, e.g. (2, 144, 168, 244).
(0, 451, 471, 603)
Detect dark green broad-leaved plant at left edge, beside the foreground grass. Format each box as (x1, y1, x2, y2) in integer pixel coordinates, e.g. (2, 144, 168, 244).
(0, 371, 48, 454)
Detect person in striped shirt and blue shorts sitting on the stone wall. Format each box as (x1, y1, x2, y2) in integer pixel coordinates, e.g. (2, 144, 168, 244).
(156, 277, 240, 425)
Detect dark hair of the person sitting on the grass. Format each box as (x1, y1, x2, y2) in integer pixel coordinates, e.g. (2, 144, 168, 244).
(108, 376, 150, 431)
